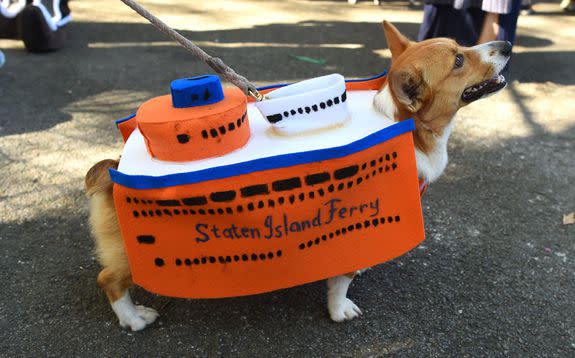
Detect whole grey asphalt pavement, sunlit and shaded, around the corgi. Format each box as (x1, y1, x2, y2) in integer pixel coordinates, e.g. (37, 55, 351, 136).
(0, 0, 575, 357)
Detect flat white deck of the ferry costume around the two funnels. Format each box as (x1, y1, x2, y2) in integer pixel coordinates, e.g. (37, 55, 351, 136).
(118, 91, 394, 176)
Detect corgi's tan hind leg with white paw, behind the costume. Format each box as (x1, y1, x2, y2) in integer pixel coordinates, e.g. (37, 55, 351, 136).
(86, 160, 158, 331)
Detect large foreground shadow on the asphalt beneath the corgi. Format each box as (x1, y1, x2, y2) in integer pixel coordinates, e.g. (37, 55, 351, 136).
(0, 119, 575, 357)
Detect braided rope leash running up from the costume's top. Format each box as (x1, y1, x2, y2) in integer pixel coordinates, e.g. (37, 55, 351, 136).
(121, 0, 263, 101)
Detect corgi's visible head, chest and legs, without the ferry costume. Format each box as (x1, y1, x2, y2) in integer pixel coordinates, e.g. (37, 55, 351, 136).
(86, 21, 511, 331)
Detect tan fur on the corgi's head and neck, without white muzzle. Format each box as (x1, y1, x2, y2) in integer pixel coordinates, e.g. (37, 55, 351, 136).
(383, 21, 495, 153)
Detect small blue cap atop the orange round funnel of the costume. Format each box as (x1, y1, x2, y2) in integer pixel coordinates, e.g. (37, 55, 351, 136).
(170, 75, 224, 108)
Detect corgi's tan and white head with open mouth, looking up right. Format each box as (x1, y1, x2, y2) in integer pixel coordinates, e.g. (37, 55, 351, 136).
(383, 21, 511, 134)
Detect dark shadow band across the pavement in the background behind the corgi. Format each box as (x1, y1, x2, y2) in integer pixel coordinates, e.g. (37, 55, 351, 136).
(0, 21, 575, 136)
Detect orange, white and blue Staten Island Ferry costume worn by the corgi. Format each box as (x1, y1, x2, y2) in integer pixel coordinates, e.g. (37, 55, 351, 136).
(110, 74, 425, 298)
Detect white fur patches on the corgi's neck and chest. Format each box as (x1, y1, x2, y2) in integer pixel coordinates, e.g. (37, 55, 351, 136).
(373, 86, 453, 182)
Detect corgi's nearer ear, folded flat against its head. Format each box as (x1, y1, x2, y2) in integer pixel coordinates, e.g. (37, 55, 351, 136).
(387, 69, 427, 113)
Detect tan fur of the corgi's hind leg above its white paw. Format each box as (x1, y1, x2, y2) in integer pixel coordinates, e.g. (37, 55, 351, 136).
(86, 159, 133, 303)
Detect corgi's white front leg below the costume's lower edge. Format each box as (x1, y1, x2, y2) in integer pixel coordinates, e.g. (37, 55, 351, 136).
(327, 272, 361, 322)
